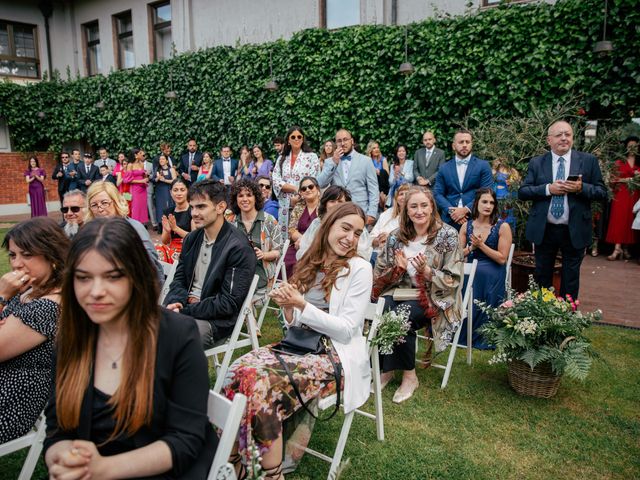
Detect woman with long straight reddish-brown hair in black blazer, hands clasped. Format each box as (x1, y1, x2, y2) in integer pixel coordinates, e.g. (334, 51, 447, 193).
(44, 218, 217, 479)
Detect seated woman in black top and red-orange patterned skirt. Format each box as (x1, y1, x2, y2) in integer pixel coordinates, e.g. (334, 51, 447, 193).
(156, 177, 193, 263)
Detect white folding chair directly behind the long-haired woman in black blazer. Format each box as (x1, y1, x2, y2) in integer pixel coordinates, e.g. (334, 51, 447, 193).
(207, 390, 247, 480)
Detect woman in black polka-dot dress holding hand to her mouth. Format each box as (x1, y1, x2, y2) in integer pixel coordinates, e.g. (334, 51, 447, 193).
(0, 217, 69, 444)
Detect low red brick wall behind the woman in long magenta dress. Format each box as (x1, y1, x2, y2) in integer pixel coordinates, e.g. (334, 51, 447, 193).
(0, 152, 58, 205)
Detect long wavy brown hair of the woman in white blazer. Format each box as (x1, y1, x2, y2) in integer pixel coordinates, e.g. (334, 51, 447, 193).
(291, 202, 366, 301)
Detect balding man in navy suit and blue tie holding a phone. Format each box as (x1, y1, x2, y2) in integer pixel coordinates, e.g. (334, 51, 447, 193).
(518, 121, 607, 299)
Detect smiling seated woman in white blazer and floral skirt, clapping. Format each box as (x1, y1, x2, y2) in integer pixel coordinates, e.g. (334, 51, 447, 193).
(224, 202, 373, 479)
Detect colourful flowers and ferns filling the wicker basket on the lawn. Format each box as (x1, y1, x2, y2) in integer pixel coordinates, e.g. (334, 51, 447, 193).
(476, 277, 602, 380)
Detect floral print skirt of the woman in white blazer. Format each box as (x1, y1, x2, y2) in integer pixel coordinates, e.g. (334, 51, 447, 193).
(223, 346, 344, 471)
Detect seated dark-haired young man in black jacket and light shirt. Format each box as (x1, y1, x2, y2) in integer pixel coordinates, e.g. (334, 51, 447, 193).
(164, 180, 257, 348)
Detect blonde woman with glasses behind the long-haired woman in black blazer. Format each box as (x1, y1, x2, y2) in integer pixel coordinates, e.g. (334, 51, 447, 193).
(85, 182, 164, 285)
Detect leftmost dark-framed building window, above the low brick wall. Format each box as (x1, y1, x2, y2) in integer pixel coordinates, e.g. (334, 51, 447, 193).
(0, 20, 40, 78)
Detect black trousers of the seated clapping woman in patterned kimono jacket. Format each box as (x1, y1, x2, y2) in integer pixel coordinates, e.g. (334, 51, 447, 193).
(380, 295, 430, 372)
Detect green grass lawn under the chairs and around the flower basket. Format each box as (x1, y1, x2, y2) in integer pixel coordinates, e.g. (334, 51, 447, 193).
(0, 227, 640, 480)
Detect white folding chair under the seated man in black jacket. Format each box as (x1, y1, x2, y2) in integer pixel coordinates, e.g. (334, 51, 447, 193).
(209, 275, 259, 392)
